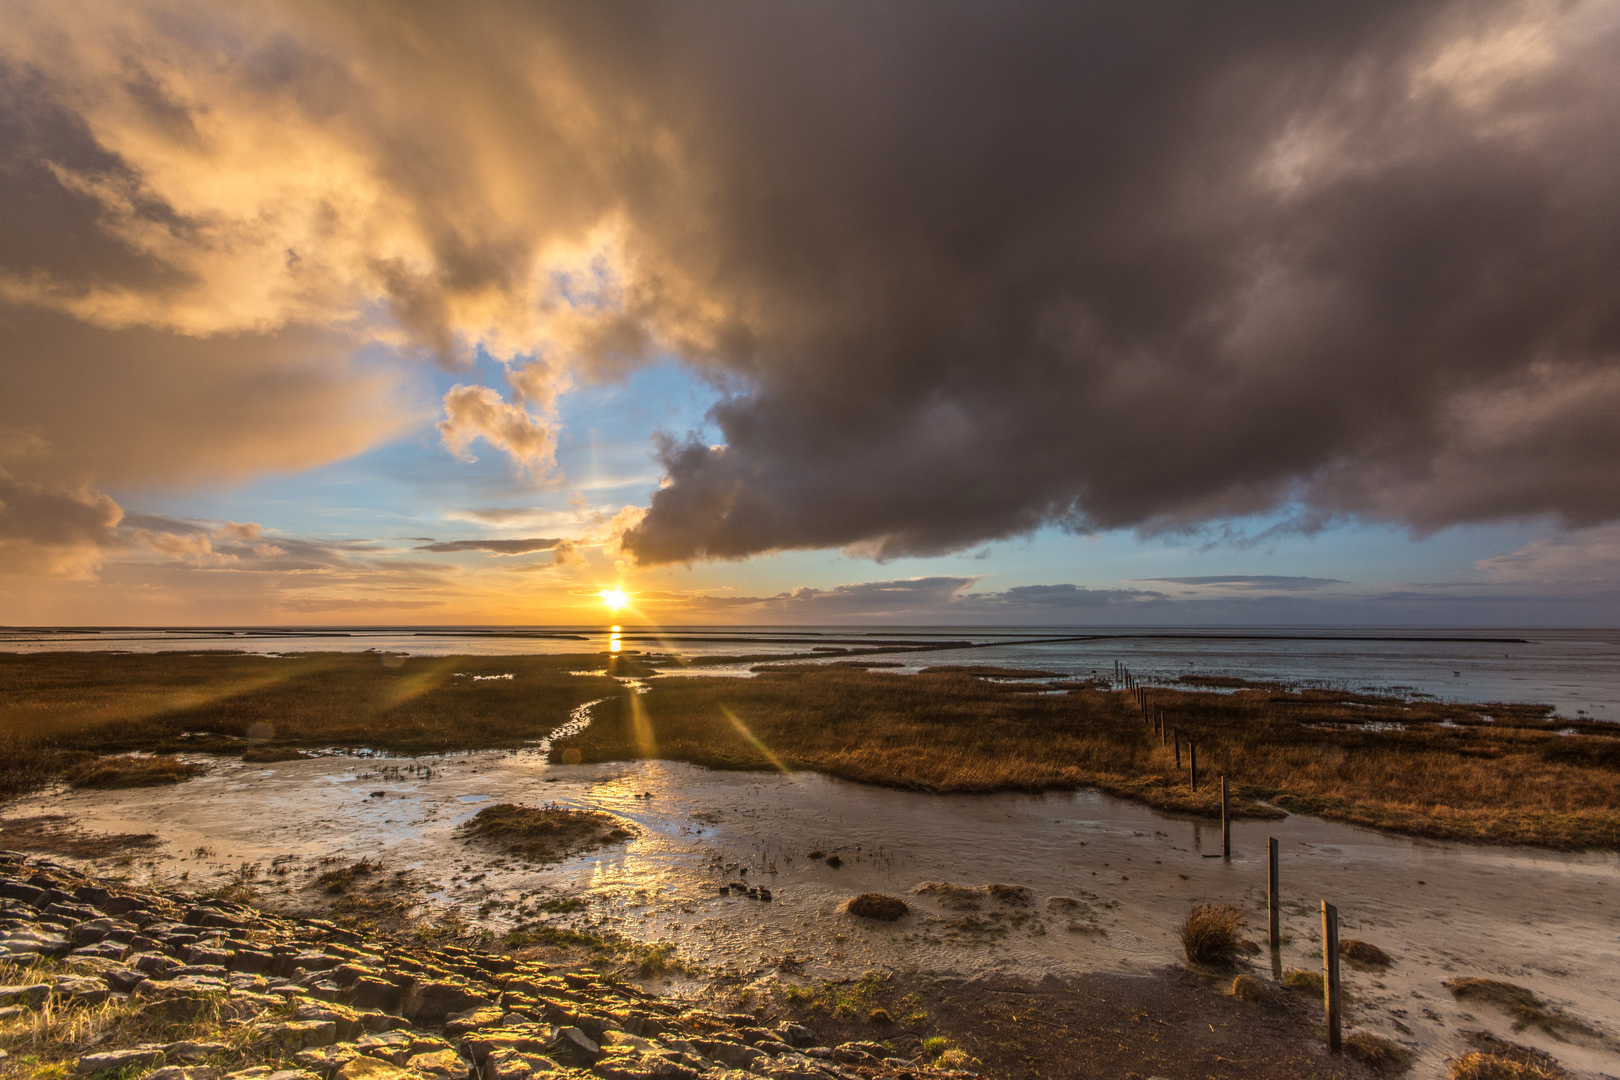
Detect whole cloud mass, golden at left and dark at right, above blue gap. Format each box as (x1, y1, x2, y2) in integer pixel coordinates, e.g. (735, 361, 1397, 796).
(0, 0, 1620, 582)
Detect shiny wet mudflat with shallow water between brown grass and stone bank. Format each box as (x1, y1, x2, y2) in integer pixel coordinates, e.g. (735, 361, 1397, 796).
(10, 751, 1620, 1075)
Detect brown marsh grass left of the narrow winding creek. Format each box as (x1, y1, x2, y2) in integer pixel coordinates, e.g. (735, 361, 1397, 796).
(0, 653, 635, 798)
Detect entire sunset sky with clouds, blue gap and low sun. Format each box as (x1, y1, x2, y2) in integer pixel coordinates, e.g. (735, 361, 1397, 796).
(0, 0, 1620, 627)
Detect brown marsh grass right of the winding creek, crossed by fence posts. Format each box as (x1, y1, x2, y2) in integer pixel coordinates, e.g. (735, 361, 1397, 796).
(552, 667, 1620, 850)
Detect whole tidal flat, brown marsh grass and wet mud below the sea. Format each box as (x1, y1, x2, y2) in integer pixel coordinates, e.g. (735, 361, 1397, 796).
(3, 654, 1620, 1077)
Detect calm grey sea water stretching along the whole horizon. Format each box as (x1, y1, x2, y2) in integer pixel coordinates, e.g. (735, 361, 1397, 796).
(0, 625, 1620, 722)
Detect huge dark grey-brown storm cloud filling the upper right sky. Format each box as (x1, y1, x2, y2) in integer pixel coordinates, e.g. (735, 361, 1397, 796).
(602, 3, 1620, 562)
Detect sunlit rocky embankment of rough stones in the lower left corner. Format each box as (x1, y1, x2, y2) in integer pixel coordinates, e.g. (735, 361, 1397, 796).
(0, 852, 967, 1080)
